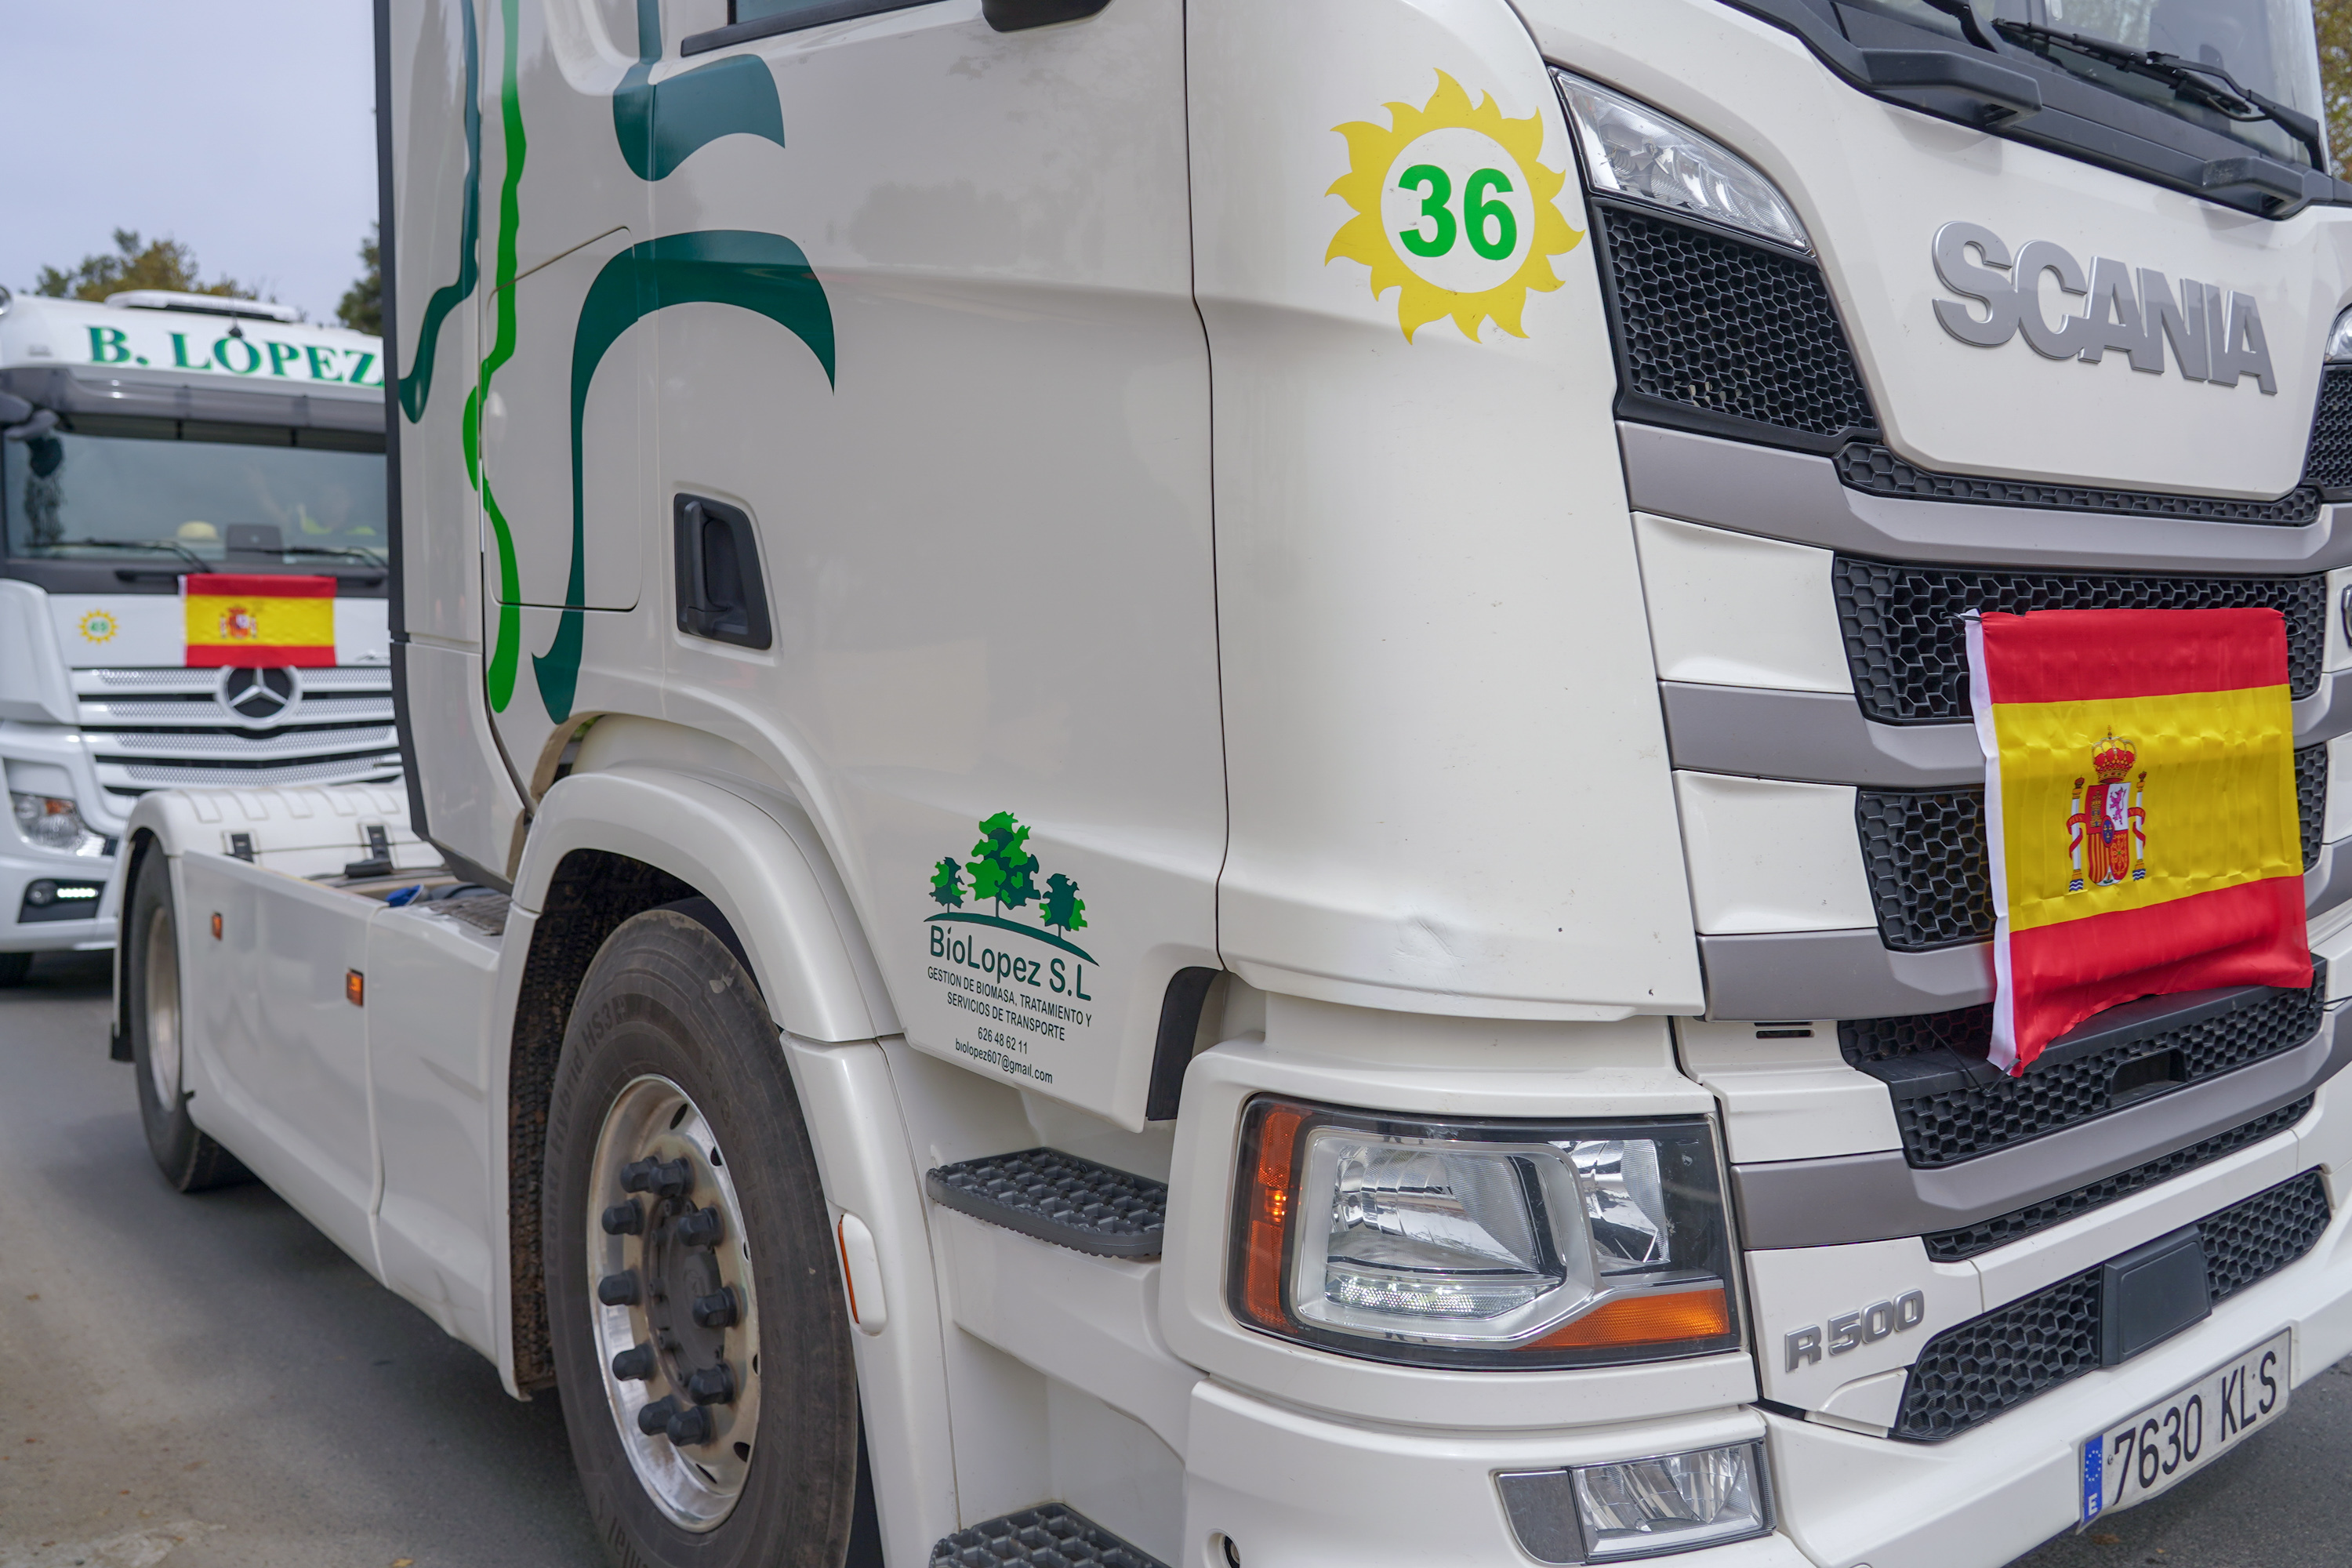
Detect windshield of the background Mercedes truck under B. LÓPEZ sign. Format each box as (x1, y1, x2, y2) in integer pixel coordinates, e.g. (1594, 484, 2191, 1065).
(0, 414, 386, 569)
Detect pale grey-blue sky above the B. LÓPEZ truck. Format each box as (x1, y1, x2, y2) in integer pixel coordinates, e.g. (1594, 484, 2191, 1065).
(0, 0, 376, 322)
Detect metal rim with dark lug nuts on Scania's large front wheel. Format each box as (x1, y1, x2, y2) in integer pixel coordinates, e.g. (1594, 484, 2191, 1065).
(583, 1074, 760, 1530)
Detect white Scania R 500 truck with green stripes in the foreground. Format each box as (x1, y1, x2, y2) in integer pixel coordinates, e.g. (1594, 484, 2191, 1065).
(108, 0, 2352, 1568)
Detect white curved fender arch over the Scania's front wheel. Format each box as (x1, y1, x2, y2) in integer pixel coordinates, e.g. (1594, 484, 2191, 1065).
(515, 762, 898, 1041)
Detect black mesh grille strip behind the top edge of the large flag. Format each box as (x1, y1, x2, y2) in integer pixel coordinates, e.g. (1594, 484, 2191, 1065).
(1830, 555, 2328, 724)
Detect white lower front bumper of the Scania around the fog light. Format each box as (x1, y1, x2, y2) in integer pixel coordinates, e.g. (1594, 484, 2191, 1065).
(1183, 1189, 2352, 1568)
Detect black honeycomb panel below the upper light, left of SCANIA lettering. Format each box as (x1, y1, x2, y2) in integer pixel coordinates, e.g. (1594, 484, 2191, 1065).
(1595, 202, 1877, 437)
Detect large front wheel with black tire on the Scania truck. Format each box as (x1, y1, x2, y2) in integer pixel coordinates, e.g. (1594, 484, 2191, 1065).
(539, 909, 858, 1568)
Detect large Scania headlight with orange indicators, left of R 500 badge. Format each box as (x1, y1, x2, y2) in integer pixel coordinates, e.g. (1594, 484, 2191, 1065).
(1228, 1098, 1740, 1368)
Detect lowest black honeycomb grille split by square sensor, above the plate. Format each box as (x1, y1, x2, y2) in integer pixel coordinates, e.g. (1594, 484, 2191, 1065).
(1893, 1171, 2328, 1443)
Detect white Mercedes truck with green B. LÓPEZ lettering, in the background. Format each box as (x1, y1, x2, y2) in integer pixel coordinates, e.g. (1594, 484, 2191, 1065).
(0, 289, 400, 987)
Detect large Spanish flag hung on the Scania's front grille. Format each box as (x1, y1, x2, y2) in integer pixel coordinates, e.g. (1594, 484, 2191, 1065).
(1969, 609, 2312, 1072)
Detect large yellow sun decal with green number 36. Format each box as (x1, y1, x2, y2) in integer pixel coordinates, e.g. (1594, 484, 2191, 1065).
(1324, 71, 1585, 343)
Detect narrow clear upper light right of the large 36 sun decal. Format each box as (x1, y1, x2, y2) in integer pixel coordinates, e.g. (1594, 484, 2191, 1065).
(1552, 71, 1813, 252)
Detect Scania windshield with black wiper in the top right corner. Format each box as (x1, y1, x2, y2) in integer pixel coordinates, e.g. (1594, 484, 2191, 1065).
(1837, 0, 2326, 169)
